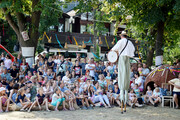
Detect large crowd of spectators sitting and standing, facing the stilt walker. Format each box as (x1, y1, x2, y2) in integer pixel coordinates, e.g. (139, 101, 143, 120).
(0, 53, 180, 112)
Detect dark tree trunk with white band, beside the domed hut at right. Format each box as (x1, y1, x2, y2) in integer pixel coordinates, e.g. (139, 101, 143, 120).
(156, 21, 164, 66)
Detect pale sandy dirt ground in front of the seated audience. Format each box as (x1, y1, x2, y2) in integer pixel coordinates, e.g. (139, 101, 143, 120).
(0, 106, 180, 120)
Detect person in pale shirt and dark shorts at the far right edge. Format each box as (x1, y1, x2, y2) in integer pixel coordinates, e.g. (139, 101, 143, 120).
(169, 73, 180, 109)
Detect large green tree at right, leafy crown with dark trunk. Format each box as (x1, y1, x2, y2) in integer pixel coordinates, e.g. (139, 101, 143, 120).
(104, 0, 180, 65)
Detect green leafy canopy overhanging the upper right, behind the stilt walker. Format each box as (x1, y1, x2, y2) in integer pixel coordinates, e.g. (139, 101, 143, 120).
(104, 0, 180, 65)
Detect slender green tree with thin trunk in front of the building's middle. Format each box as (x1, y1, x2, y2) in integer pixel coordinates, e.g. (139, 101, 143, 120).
(66, 0, 109, 53)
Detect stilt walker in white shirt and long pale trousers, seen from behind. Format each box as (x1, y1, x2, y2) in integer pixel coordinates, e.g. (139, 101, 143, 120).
(112, 31, 135, 113)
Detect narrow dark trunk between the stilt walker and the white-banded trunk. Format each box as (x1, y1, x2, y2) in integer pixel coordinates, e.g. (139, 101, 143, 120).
(146, 47, 154, 67)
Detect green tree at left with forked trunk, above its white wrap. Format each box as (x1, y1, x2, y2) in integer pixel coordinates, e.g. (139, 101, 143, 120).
(0, 0, 62, 61)
